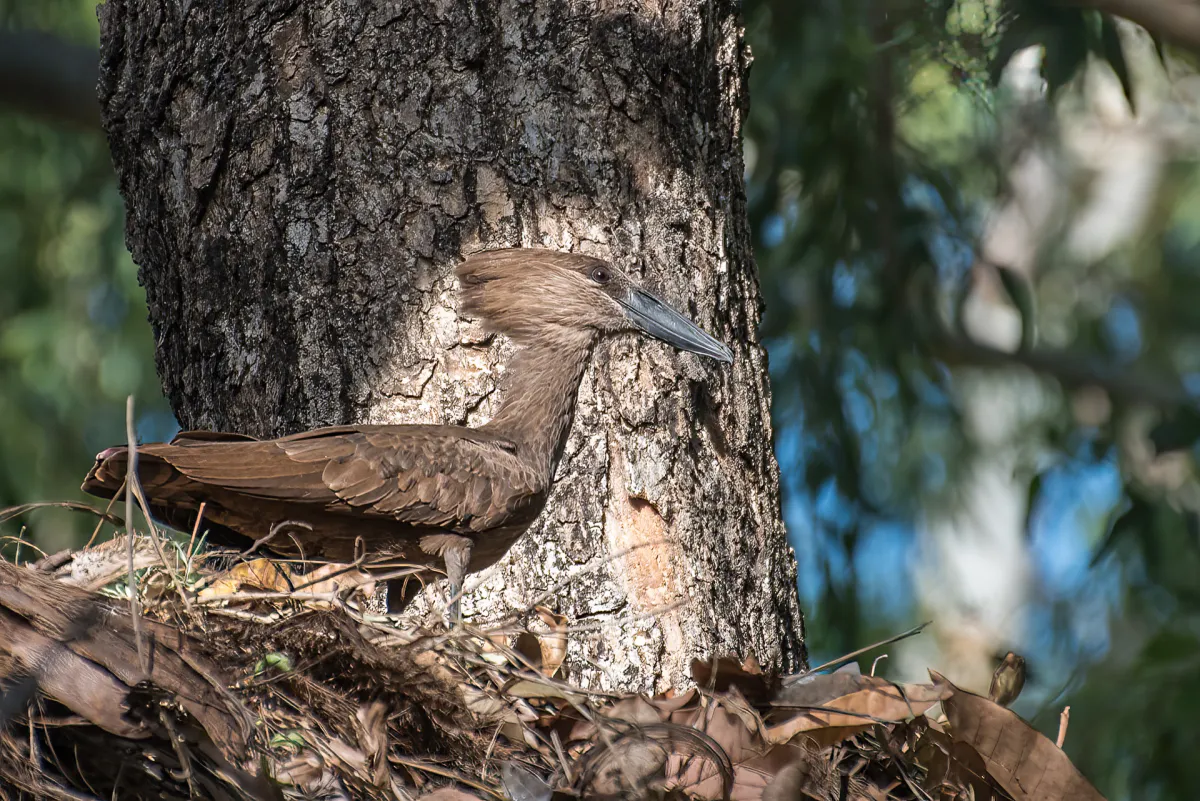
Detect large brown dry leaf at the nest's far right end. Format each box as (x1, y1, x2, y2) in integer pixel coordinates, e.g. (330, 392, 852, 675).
(929, 670, 1104, 801)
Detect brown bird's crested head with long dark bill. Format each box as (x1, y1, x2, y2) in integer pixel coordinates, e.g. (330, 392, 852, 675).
(457, 248, 733, 362)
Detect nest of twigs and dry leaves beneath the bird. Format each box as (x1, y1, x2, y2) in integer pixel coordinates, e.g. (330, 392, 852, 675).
(0, 527, 1100, 801)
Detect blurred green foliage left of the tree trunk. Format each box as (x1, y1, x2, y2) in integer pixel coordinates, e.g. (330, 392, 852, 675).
(0, 0, 172, 550)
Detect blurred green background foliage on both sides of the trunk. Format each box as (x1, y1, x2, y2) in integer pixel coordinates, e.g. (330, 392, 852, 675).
(0, 0, 1200, 801)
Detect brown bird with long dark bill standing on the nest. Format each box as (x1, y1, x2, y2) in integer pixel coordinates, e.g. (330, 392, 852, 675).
(83, 249, 733, 619)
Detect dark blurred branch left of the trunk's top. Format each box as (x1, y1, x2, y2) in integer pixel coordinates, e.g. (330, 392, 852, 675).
(0, 30, 101, 131)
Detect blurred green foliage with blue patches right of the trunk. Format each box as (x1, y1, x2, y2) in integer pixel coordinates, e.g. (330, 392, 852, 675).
(746, 0, 1200, 800)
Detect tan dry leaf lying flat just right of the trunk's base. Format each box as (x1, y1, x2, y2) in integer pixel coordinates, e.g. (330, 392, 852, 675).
(767, 673, 948, 745)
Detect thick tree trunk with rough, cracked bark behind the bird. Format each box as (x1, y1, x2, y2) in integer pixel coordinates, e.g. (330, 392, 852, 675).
(100, 0, 803, 688)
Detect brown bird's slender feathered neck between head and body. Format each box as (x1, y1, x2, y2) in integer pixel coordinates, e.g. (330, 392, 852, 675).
(484, 332, 595, 484)
